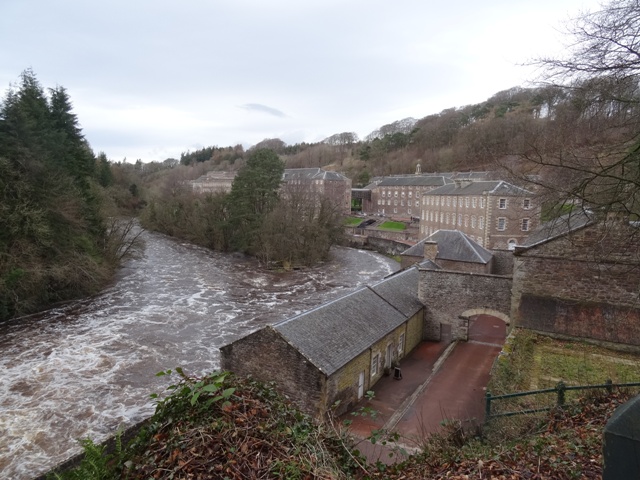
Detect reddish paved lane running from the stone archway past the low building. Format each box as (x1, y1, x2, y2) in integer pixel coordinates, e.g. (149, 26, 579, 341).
(350, 315, 506, 463)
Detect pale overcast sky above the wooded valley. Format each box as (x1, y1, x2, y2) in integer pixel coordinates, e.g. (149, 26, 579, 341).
(0, 0, 598, 162)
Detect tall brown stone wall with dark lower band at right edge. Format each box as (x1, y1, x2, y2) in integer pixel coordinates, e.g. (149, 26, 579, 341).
(511, 220, 640, 346)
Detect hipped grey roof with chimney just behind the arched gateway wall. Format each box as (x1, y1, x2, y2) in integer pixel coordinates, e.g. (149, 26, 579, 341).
(401, 230, 493, 264)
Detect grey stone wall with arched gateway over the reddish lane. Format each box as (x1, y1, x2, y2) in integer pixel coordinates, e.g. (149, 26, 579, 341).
(418, 269, 511, 341)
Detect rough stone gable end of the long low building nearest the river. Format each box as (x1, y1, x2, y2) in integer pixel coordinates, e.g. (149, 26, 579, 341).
(220, 327, 327, 416)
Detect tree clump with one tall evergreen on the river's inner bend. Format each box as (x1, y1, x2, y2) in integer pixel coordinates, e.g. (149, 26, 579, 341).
(140, 149, 342, 268)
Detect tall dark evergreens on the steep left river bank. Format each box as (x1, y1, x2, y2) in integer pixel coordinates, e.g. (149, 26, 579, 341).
(0, 70, 141, 321)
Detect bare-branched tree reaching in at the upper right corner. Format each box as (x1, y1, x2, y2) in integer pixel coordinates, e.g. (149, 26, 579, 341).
(503, 0, 640, 218)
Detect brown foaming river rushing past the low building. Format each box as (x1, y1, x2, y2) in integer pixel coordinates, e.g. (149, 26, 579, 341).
(0, 233, 398, 479)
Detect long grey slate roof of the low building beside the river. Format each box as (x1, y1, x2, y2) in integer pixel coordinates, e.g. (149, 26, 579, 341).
(267, 268, 423, 375)
